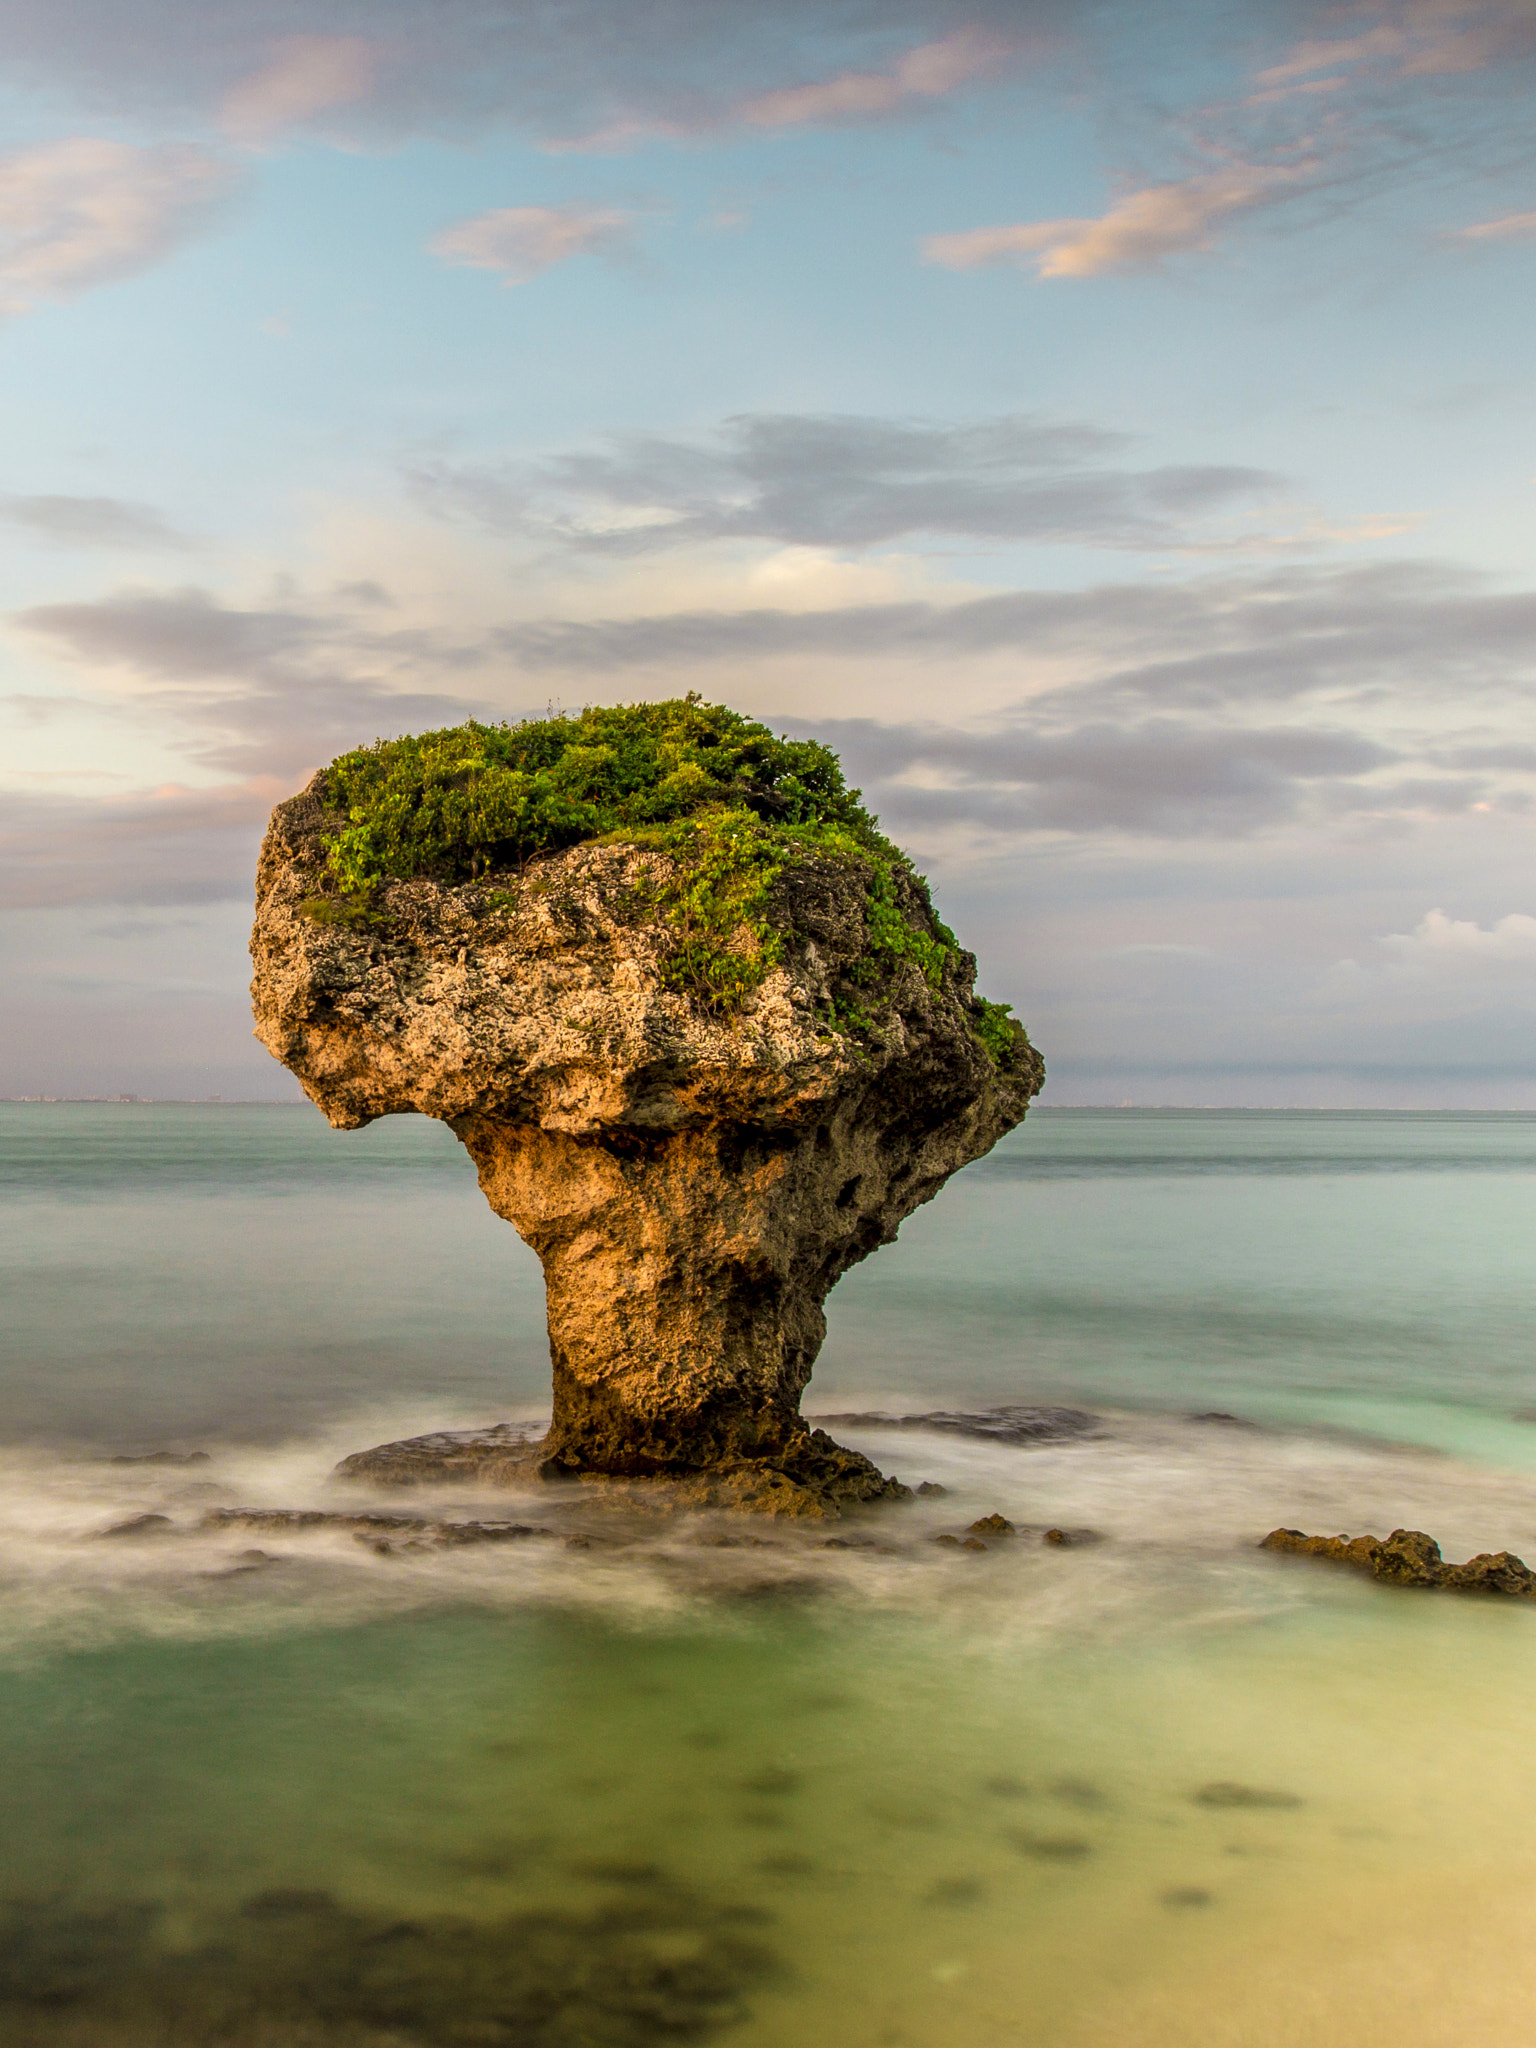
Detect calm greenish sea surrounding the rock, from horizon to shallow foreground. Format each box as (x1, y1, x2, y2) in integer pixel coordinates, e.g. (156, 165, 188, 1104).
(0, 1102, 1536, 2048)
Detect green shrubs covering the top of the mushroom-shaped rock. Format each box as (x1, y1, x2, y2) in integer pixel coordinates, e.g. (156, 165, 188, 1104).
(307, 694, 1020, 1067)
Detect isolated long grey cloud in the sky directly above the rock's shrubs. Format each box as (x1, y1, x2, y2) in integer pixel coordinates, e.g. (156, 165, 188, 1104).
(412, 414, 1280, 553)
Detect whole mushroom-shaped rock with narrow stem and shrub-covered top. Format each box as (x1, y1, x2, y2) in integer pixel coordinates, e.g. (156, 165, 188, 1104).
(252, 698, 1044, 1511)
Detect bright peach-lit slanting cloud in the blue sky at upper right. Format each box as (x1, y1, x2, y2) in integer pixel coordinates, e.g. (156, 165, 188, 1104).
(922, 164, 1307, 276)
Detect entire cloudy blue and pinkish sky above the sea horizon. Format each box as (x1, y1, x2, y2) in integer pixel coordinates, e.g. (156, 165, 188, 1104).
(0, 0, 1536, 1110)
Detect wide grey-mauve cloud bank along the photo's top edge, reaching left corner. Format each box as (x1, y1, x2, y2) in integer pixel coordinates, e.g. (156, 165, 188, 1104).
(6, 0, 1077, 145)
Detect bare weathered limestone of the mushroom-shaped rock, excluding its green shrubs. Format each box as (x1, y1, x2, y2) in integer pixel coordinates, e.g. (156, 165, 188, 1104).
(252, 784, 1044, 1505)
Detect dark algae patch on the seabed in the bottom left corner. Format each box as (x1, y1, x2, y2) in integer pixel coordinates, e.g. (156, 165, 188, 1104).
(0, 1878, 770, 2048)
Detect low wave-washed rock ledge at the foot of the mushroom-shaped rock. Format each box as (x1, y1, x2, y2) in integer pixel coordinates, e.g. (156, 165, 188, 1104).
(336, 1423, 911, 1522)
